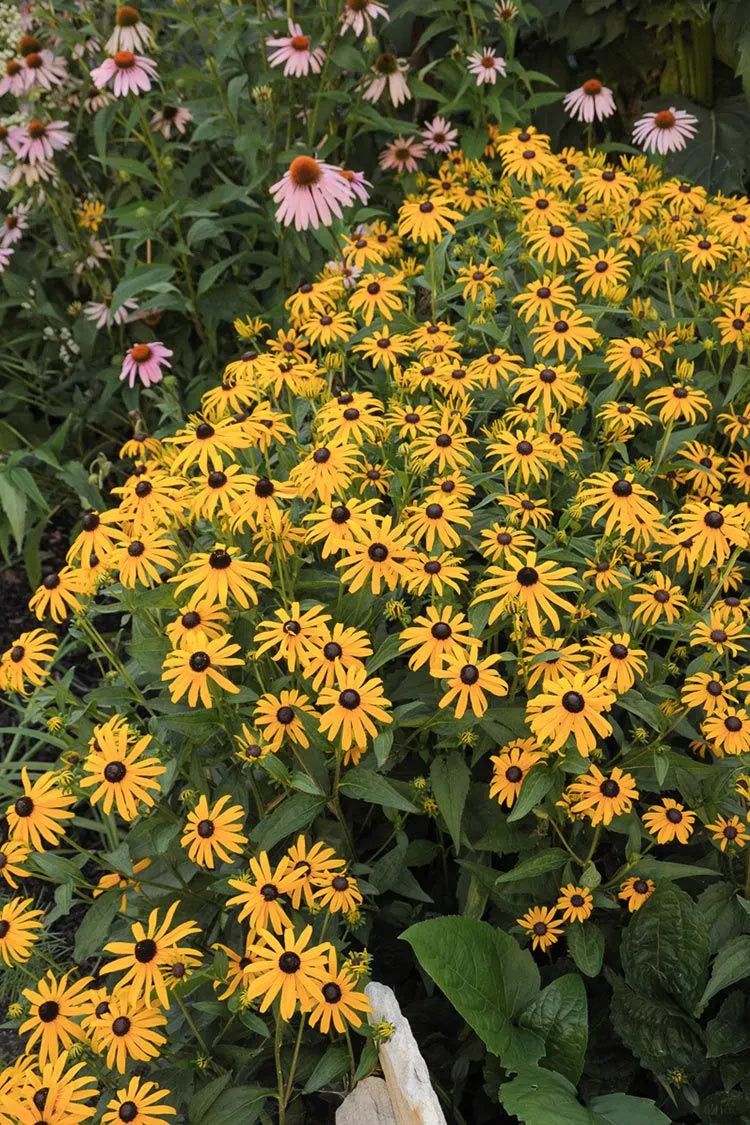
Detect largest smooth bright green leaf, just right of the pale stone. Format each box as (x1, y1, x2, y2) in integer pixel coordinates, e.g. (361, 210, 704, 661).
(401, 917, 544, 1070)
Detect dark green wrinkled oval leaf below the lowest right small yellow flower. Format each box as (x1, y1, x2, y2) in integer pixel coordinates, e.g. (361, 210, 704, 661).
(620, 883, 706, 1011)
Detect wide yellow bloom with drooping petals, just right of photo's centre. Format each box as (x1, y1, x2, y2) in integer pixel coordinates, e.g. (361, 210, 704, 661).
(471, 551, 578, 635)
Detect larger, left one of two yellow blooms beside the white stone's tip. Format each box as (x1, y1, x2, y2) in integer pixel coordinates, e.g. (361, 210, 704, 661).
(244, 926, 331, 1020)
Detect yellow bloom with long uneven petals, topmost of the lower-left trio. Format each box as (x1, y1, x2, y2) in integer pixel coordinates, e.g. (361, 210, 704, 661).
(100, 900, 200, 1008)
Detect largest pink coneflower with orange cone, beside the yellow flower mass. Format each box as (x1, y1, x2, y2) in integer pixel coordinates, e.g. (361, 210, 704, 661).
(270, 156, 352, 231)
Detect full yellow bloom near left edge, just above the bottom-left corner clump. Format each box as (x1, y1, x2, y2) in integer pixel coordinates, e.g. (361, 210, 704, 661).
(18, 969, 91, 1067)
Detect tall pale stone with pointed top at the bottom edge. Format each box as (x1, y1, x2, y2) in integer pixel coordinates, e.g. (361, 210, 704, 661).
(366, 981, 446, 1125)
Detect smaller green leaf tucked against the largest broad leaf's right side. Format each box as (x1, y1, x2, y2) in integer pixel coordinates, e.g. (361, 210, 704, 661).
(521, 973, 588, 1082)
